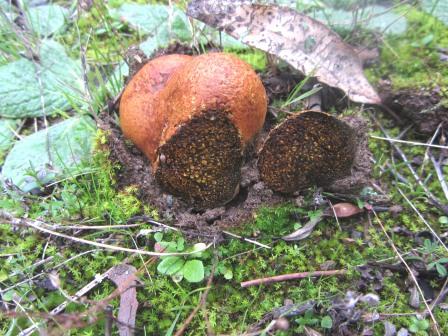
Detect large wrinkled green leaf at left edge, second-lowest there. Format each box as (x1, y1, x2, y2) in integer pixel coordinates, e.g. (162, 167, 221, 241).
(0, 40, 84, 118)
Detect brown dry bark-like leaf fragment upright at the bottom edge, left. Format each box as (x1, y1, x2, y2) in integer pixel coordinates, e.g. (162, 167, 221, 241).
(108, 264, 138, 336)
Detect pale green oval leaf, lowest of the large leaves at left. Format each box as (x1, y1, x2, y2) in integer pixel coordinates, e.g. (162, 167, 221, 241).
(2, 117, 96, 192)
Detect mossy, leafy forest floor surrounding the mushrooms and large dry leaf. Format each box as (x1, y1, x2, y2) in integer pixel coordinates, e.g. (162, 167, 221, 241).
(0, 0, 448, 336)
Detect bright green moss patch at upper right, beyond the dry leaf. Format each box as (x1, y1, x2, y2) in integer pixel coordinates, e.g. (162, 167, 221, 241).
(367, 7, 448, 89)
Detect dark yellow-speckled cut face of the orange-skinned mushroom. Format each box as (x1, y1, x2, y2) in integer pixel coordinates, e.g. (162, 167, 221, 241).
(155, 111, 243, 208)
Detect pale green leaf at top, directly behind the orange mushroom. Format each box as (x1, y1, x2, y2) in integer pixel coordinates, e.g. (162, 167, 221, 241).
(111, 4, 192, 56)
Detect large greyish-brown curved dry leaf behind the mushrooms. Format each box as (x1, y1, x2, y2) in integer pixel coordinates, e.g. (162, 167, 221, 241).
(187, 0, 381, 104)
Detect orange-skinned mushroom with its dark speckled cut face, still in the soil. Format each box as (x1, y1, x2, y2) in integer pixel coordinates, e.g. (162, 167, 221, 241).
(120, 53, 267, 208)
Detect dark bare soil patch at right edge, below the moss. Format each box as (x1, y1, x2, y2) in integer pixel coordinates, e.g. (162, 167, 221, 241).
(382, 83, 448, 134)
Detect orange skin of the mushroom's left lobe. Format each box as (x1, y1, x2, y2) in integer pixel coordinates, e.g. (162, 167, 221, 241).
(120, 54, 192, 162)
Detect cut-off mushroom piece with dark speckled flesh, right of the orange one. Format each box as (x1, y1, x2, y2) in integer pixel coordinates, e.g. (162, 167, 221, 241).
(258, 111, 356, 194)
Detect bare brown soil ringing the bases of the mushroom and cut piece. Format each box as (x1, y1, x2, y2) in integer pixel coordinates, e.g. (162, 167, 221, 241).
(99, 45, 371, 233)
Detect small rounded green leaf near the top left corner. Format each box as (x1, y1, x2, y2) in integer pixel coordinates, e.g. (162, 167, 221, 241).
(26, 4, 69, 37)
